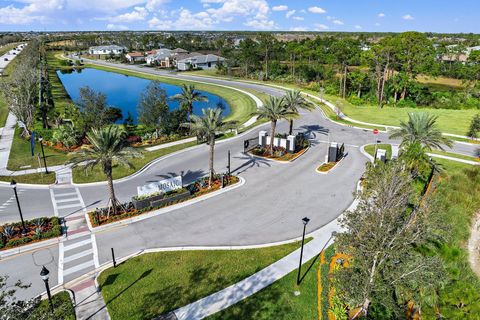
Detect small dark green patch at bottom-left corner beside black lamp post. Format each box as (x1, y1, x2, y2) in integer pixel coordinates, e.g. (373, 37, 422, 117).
(29, 291, 76, 320)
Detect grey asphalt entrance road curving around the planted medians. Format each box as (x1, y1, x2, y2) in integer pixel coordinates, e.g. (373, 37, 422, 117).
(0, 62, 476, 295)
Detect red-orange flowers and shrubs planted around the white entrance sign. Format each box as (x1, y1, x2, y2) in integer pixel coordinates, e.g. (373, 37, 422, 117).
(88, 176, 240, 227)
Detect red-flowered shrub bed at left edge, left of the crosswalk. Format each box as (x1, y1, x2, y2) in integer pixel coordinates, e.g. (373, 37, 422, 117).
(0, 217, 62, 250)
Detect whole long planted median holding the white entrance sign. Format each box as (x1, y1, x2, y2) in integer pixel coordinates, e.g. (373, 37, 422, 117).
(88, 175, 242, 228)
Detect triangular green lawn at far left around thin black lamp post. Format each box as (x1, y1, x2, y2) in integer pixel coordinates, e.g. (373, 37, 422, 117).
(7, 128, 70, 171)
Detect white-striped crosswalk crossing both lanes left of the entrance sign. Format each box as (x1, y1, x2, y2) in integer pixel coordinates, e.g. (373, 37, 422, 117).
(50, 185, 99, 284)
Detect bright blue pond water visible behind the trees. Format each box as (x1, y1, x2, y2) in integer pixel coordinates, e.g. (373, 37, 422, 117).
(57, 68, 230, 123)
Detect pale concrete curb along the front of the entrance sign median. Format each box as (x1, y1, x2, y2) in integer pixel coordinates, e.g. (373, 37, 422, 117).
(87, 177, 246, 233)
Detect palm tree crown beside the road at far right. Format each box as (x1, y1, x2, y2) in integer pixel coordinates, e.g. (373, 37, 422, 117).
(390, 112, 452, 151)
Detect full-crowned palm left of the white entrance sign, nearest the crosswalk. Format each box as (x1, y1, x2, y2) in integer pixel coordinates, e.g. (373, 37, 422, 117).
(72, 126, 142, 215)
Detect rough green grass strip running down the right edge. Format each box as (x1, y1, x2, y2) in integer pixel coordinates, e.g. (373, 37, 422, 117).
(422, 159, 480, 319)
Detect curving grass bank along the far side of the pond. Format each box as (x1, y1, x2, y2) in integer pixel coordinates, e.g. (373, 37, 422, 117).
(85, 64, 257, 124)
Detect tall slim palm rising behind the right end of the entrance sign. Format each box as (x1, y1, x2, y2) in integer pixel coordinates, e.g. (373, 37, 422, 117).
(185, 108, 235, 187)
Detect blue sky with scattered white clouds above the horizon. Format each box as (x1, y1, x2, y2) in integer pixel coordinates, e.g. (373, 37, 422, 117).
(0, 0, 480, 33)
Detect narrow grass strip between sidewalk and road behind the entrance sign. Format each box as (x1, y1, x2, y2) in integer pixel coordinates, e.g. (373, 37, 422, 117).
(73, 142, 199, 183)
